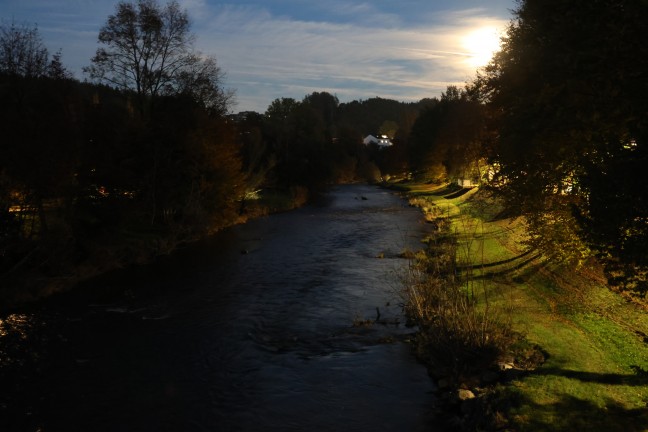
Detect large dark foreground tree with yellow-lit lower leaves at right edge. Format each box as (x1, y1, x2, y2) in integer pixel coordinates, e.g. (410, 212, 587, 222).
(476, 0, 648, 294)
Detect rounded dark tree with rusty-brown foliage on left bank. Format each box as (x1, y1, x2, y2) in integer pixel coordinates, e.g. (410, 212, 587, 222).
(148, 97, 246, 231)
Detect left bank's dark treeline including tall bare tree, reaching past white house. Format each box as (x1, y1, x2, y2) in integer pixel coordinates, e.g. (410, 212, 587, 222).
(0, 4, 436, 306)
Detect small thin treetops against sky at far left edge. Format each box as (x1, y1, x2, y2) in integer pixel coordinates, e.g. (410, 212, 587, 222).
(0, 21, 49, 78)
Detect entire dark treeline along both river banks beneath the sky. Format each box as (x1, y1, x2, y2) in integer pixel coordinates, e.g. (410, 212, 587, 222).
(0, 0, 648, 304)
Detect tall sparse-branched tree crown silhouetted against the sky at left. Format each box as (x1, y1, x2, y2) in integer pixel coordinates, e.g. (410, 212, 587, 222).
(84, 0, 232, 113)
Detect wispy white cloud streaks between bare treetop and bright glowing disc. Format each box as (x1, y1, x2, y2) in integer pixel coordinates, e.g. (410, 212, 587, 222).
(194, 2, 506, 111)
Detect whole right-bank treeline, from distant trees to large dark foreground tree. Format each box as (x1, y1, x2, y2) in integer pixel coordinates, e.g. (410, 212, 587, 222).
(409, 0, 648, 298)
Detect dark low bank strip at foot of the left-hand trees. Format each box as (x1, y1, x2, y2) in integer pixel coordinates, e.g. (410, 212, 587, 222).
(0, 188, 308, 314)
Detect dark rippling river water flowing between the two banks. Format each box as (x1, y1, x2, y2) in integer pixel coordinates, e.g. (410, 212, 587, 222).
(0, 185, 440, 432)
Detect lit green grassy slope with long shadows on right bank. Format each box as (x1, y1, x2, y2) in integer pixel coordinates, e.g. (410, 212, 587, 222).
(399, 185, 648, 432)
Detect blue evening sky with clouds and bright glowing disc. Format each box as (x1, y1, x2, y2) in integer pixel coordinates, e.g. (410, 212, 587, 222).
(0, 0, 516, 113)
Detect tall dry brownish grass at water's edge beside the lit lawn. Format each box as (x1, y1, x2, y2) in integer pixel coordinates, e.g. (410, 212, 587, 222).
(404, 198, 515, 384)
